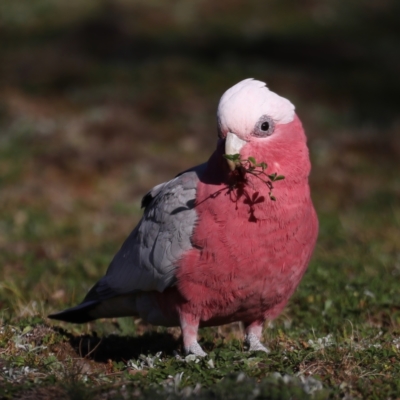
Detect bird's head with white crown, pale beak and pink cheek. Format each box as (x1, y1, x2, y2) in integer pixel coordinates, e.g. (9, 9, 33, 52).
(217, 79, 304, 170)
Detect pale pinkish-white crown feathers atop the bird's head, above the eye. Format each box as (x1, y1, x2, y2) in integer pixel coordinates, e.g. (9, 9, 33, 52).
(217, 78, 294, 134)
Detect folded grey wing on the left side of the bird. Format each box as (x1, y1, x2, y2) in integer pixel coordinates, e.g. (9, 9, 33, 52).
(85, 164, 205, 301)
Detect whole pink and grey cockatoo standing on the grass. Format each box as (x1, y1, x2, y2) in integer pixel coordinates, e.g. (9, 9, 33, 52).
(50, 79, 318, 356)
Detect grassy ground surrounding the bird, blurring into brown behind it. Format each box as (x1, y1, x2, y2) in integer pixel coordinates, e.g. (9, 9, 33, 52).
(0, 0, 400, 399)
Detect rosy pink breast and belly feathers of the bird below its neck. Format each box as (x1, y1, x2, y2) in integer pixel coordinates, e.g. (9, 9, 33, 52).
(173, 167, 317, 325)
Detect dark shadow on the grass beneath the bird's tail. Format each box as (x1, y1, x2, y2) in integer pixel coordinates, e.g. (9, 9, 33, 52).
(56, 331, 181, 363)
